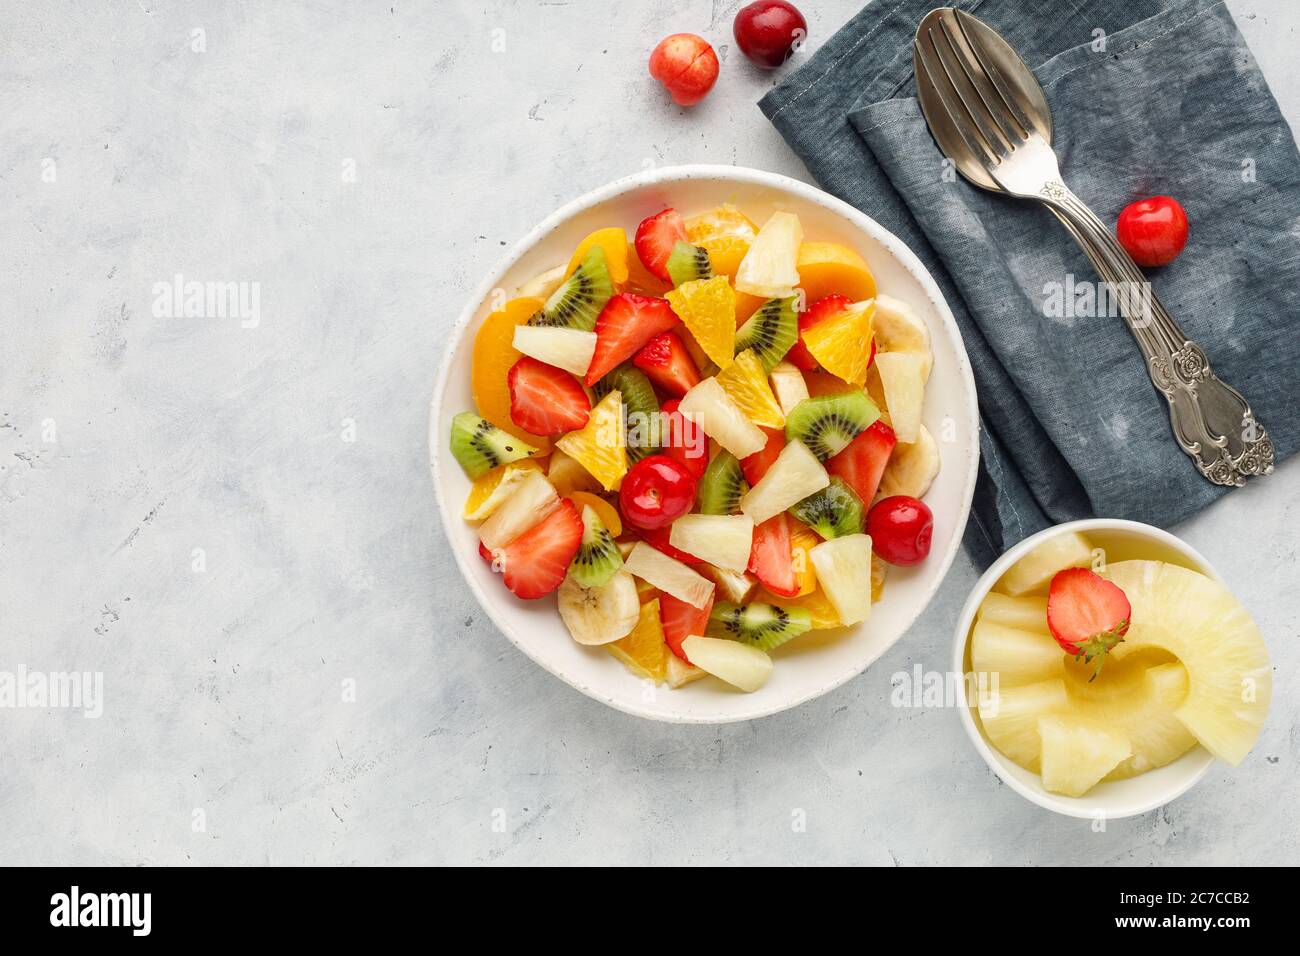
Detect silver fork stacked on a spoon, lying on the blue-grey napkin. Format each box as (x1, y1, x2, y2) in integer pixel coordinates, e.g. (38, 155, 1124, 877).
(913, 7, 1274, 485)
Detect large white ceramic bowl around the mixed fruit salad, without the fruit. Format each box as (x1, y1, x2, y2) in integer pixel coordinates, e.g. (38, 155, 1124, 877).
(429, 165, 979, 723)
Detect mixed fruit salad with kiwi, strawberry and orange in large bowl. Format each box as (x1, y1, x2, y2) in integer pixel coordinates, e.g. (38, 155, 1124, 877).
(449, 206, 939, 691)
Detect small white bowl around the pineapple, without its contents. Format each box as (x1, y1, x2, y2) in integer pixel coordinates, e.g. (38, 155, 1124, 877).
(953, 518, 1223, 819)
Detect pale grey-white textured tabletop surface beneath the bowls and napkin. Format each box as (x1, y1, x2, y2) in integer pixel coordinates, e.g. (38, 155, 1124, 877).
(0, 0, 1300, 864)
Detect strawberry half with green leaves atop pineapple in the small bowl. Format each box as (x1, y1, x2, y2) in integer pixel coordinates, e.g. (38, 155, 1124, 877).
(1048, 567, 1132, 680)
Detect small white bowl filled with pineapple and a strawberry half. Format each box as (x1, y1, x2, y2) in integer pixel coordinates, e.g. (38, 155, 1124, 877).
(953, 519, 1271, 818)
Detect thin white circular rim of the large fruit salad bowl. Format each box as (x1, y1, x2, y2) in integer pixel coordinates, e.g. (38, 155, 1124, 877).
(429, 164, 979, 724)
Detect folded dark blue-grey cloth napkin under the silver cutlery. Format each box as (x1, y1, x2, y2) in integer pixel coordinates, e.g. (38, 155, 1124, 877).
(759, 0, 1300, 563)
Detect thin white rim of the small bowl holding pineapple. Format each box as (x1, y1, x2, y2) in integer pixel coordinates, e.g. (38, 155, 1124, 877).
(953, 518, 1227, 819)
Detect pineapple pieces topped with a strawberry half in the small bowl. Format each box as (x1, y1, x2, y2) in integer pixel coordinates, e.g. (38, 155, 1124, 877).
(969, 532, 1271, 797)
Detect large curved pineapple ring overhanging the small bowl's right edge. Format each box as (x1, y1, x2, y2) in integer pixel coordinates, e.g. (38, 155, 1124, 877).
(1105, 561, 1273, 765)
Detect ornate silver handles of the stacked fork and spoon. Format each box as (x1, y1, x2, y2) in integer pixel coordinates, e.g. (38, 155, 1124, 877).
(1040, 181, 1274, 485)
